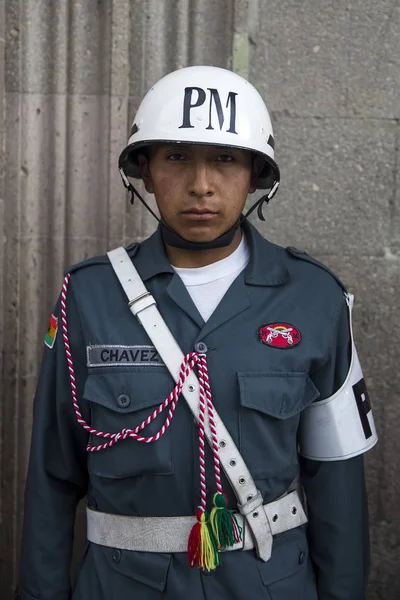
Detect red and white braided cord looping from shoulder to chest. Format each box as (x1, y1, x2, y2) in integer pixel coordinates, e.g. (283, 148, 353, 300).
(61, 273, 227, 504)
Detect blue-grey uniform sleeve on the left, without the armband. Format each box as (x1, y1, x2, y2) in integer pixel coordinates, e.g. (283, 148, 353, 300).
(17, 284, 88, 600)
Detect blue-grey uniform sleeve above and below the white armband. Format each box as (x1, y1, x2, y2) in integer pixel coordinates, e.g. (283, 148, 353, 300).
(300, 301, 369, 600)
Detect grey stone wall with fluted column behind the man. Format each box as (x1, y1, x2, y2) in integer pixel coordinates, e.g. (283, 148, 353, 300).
(0, 0, 400, 600)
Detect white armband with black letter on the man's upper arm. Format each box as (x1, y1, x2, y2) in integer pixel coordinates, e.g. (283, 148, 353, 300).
(299, 294, 378, 461)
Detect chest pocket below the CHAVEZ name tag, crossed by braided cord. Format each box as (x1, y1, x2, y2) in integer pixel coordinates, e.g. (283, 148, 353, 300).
(83, 368, 174, 479)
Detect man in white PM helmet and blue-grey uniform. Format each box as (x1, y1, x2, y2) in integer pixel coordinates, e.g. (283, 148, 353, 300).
(18, 67, 377, 600)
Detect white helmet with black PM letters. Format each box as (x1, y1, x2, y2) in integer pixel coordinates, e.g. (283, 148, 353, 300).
(119, 66, 280, 199)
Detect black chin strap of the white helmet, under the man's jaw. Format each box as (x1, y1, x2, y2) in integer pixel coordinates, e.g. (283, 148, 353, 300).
(119, 168, 279, 251)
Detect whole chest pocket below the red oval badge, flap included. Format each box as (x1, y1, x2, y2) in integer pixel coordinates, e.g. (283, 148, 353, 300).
(238, 372, 319, 478)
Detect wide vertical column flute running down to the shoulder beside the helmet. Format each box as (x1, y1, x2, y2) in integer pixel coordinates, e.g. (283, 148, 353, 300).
(66, 0, 115, 264)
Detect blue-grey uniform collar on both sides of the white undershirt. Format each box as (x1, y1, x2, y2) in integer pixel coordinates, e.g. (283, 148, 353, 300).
(128, 220, 289, 286)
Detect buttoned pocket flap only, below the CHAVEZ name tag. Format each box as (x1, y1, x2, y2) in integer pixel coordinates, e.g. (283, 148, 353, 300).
(83, 371, 175, 413)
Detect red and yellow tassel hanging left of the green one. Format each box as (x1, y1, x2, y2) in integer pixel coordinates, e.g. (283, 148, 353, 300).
(188, 510, 219, 571)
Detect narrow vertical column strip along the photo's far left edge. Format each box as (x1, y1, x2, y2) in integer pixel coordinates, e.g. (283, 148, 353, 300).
(0, 2, 23, 597)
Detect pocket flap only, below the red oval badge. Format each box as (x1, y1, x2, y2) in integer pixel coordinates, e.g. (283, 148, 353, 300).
(238, 372, 319, 419)
